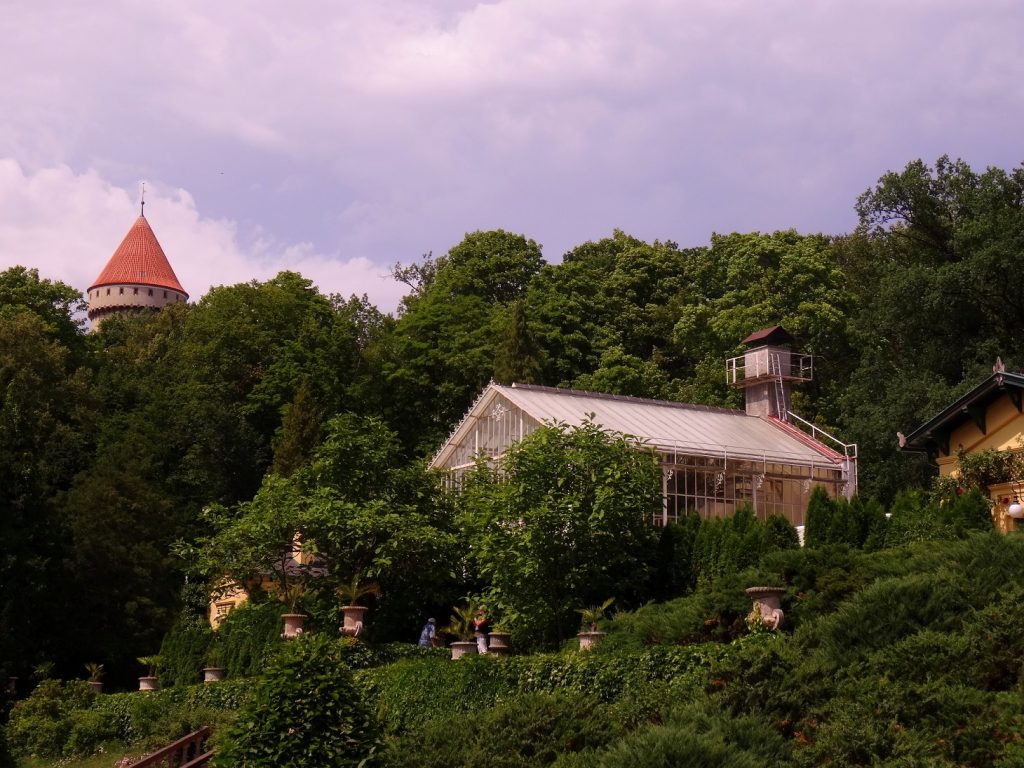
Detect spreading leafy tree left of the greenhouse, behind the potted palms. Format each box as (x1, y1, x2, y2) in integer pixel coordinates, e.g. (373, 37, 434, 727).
(184, 414, 458, 637)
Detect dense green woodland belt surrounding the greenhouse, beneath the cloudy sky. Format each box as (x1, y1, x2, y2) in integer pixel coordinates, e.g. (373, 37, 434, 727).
(6, 151, 1024, 720)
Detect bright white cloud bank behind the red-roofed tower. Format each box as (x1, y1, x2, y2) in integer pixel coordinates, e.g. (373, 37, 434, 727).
(0, 158, 402, 311)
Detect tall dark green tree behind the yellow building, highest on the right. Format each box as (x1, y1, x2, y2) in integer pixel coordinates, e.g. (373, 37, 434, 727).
(842, 157, 1024, 502)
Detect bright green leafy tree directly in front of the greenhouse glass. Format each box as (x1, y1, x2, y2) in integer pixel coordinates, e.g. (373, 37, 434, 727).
(459, 421, 660, 647)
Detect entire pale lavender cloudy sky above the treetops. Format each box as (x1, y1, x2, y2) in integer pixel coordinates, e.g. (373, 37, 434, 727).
(0, 0, 1024, 311)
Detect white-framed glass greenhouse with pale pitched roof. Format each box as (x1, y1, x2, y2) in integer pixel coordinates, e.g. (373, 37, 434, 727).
(431, 383, 856, 525)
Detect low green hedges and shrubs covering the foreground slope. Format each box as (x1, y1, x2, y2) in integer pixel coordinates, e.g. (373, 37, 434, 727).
(7, 528, 1024, 768)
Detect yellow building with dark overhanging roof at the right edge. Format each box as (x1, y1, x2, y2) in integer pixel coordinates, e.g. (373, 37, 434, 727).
(897, 360, 1024, 530)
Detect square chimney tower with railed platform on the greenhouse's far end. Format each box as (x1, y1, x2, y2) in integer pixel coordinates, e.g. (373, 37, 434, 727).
(726, 326, 814, 421)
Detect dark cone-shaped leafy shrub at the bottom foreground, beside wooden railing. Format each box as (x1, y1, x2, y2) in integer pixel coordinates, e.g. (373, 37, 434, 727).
(217, 635, 380, 768)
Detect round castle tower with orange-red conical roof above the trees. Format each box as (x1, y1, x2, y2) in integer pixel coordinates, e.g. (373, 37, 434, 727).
(88, 215, 188, 328)
